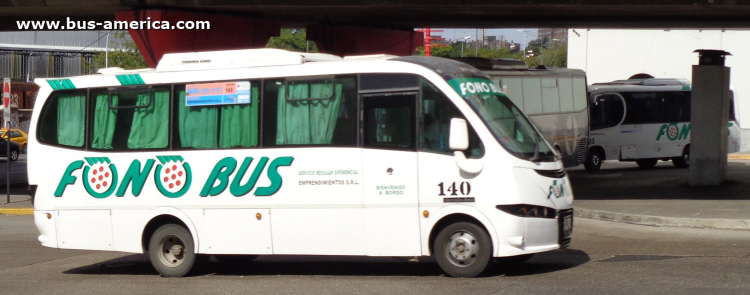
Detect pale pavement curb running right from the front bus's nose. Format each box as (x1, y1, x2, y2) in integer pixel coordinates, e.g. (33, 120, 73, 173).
(573, 208, 750, 231)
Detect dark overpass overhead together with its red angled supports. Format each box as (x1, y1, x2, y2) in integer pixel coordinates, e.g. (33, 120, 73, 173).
(0, 0, 750, 67)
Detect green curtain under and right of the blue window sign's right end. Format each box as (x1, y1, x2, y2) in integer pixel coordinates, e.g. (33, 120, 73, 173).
(219, 87, 260, 148)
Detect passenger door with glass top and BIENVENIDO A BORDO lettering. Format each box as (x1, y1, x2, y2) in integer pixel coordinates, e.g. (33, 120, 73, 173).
(361, 92, 421, 256)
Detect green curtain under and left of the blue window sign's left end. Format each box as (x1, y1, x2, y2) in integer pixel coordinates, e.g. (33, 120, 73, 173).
(177, 90, 219, 149)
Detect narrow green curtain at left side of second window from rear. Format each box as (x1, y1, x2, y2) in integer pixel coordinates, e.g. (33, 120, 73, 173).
(91, 93, 119, 150)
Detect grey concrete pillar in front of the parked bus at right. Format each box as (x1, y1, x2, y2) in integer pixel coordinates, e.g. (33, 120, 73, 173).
(688, 50, 730, 186)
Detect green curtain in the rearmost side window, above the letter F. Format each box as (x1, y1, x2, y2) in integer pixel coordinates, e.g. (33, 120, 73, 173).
(57, 94, 86, 147)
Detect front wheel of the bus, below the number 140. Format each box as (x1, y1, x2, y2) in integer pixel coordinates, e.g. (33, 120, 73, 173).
(433, 222, 492, 278)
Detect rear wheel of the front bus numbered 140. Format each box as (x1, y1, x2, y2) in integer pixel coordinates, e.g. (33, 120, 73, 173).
(148, 224, 201, 278)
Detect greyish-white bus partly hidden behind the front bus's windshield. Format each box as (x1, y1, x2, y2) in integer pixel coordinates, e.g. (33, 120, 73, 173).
(450, 57, 589, 167)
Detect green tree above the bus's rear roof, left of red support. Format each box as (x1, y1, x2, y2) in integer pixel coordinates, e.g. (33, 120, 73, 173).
(89, 31, 148, 70)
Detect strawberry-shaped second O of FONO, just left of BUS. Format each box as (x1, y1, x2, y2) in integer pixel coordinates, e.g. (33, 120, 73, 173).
(154, 156, 192, 198)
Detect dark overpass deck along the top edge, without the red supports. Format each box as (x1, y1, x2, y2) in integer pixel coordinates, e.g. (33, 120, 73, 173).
(0, 0, 750, 30)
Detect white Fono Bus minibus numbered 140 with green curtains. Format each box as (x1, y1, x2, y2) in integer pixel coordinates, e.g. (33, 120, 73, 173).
(28, 49, 573, 277)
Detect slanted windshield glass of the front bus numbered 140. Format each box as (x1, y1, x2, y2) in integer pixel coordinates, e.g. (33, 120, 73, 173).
(465, 94, 555, 161)
